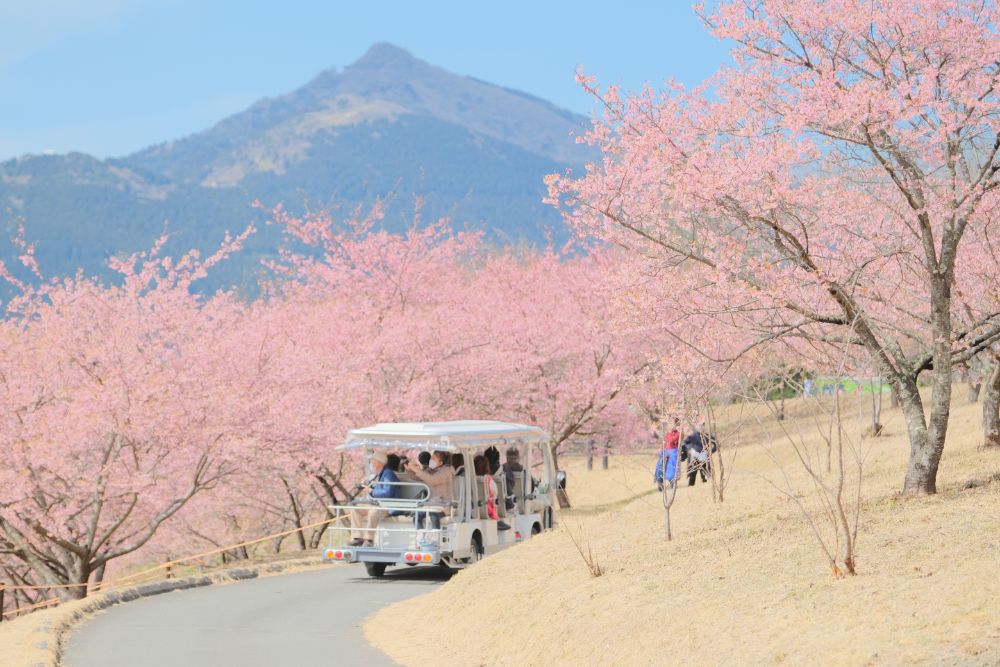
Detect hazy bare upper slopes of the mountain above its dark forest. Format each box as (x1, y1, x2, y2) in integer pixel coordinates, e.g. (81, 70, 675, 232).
(122, 42, 590, 187)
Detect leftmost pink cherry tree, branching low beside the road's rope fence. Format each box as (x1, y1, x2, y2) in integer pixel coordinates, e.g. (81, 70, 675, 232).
(0, 230, 258, 598)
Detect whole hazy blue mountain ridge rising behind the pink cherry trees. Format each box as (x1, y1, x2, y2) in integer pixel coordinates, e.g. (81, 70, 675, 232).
(0, 43, 592, 284)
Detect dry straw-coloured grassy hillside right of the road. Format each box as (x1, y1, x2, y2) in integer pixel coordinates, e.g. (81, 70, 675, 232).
(365, 392, 1000, 665)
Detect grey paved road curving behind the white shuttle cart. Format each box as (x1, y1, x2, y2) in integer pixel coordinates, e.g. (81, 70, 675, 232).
(63, 565, 448, 667)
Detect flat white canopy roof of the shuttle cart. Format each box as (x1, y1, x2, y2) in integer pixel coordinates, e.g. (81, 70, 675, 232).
(337, 419, 549, 452)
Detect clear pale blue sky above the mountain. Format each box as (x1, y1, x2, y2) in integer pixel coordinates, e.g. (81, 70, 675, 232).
(0, 0, 728, 160)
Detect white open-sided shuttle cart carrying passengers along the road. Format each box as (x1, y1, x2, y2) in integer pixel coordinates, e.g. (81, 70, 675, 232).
(323, 421, 556, 577)
